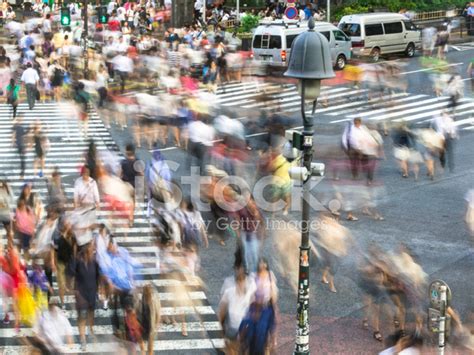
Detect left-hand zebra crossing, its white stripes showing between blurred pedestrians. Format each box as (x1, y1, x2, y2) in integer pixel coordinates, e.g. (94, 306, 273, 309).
(0, 103, 224, 354)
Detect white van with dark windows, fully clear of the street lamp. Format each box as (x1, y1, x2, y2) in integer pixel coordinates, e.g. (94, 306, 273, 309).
(338, 13, 421, 61)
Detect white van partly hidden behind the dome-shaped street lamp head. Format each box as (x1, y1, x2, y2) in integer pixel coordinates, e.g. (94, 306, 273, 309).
(252, 20, 352, 69)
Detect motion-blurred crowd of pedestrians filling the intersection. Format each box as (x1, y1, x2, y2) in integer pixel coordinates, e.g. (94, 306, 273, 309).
(0, 1, 473, 354)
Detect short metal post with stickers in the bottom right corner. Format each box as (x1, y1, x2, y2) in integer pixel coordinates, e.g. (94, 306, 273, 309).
(428, 280, 451, 355)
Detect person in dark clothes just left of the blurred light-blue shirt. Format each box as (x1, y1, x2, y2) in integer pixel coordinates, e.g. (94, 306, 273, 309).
(70, 243, 99, 351)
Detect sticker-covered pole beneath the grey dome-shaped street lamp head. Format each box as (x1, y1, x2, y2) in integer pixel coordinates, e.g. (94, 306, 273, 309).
(295, 79, 314, 355)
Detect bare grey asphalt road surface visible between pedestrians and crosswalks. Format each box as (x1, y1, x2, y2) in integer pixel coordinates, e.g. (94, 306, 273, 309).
(106, 46, 474, 353)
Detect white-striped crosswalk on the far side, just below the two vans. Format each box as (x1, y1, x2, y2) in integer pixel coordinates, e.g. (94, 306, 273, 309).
(210, 84, 474, 131)
